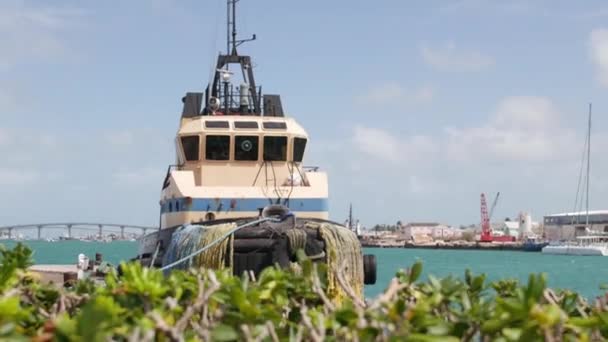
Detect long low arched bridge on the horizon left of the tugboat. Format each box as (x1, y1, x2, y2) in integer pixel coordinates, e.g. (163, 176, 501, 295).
(0, 222, 158, 240)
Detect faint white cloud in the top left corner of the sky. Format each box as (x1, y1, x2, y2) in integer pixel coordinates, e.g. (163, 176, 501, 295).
(0, 0, 83, 68)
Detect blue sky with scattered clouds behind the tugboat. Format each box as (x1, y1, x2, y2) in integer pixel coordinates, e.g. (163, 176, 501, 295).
(0, 0, 608, 230)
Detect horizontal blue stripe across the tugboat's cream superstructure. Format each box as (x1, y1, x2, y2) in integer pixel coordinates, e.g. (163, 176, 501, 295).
(160, 198, 329, 214)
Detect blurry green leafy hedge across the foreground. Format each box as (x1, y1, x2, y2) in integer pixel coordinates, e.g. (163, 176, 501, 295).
(0, 245, 608, 341)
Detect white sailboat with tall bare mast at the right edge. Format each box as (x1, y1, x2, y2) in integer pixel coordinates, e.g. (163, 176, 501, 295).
(542, 104, 608, 256)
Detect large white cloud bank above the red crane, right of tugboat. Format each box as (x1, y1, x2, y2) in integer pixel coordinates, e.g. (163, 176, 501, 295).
(353, 96, 583, 165)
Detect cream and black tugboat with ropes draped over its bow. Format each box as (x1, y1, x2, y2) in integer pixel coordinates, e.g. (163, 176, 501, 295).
(137, 0, 376, 299)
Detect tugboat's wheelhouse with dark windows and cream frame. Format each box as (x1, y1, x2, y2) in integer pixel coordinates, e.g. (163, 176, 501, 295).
(176, 115, 308, 165)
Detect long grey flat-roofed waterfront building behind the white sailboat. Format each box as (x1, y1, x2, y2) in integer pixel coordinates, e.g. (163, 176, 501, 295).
(543, 210, 608, 241)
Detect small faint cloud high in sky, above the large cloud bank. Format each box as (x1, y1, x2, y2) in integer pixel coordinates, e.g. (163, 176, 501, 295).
(420, 42, 495, 72)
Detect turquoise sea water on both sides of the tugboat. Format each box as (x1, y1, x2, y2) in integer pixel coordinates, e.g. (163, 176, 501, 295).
(2, 241, 608, 298)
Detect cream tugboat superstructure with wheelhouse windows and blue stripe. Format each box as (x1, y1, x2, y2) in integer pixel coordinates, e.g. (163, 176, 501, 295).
(160, 115, 328, 228)
